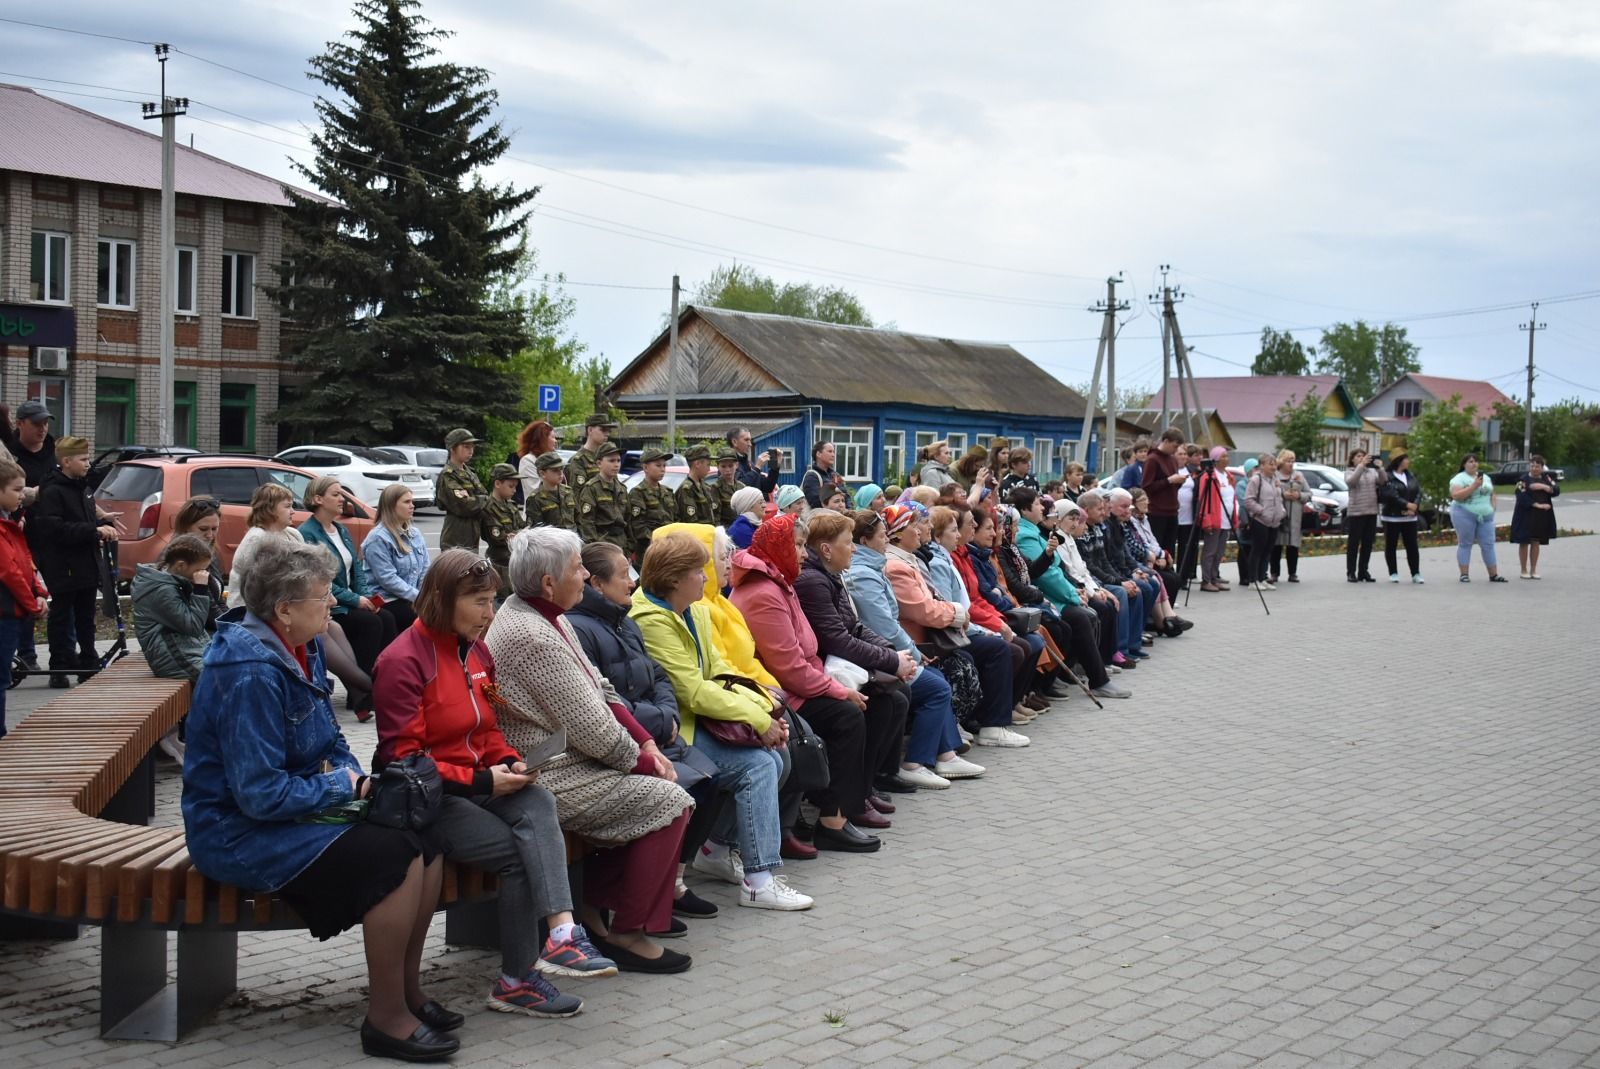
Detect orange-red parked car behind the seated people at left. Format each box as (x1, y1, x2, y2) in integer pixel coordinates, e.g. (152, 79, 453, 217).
(94, 453, 373, 579)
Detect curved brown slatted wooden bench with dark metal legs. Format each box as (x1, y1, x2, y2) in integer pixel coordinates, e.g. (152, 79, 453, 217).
(0, 656, 582, 1042)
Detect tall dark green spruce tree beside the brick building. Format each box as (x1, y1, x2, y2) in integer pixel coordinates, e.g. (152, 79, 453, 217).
(275, 0, 539, 445)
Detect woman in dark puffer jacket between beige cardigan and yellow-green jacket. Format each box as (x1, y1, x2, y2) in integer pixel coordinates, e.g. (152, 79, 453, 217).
(566, 543, 728, 935)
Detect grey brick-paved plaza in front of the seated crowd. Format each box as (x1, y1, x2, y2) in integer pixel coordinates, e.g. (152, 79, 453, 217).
(0, 509, 1600, 1069)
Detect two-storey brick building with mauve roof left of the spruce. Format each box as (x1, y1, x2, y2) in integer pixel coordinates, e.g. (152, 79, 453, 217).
(0, 85, 315, 453)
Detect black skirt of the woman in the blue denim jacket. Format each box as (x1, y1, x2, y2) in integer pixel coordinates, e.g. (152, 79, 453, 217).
(278, 824, 443, 939)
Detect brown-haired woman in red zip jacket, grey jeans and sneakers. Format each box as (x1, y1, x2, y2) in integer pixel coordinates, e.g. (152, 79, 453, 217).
(373, 549, 618, 1027)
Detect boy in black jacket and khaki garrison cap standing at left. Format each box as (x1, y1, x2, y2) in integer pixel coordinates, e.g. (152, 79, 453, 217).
(27, 437, 117, 688)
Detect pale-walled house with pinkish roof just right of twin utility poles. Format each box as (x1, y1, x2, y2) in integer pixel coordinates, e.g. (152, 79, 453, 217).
(1146, 374, 1378, 464)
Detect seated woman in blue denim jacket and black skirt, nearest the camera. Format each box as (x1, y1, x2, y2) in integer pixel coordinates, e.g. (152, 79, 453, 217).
(182, 541, 461, 1061)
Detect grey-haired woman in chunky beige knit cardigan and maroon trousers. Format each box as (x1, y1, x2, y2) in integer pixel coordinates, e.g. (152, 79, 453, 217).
(488, 526, 694, 973)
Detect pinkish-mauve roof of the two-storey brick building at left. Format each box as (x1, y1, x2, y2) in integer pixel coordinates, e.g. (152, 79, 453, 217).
(0, 83, 321, 206)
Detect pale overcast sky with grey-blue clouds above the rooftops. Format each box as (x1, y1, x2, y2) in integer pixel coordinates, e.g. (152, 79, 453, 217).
(0, 0, 1600, 402)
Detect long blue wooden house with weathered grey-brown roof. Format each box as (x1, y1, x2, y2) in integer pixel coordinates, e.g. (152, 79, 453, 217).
(606, 306, 1099, 483)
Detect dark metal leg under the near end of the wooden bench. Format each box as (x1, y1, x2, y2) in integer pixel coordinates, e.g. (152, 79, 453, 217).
(101, 925, 238, 1043)
